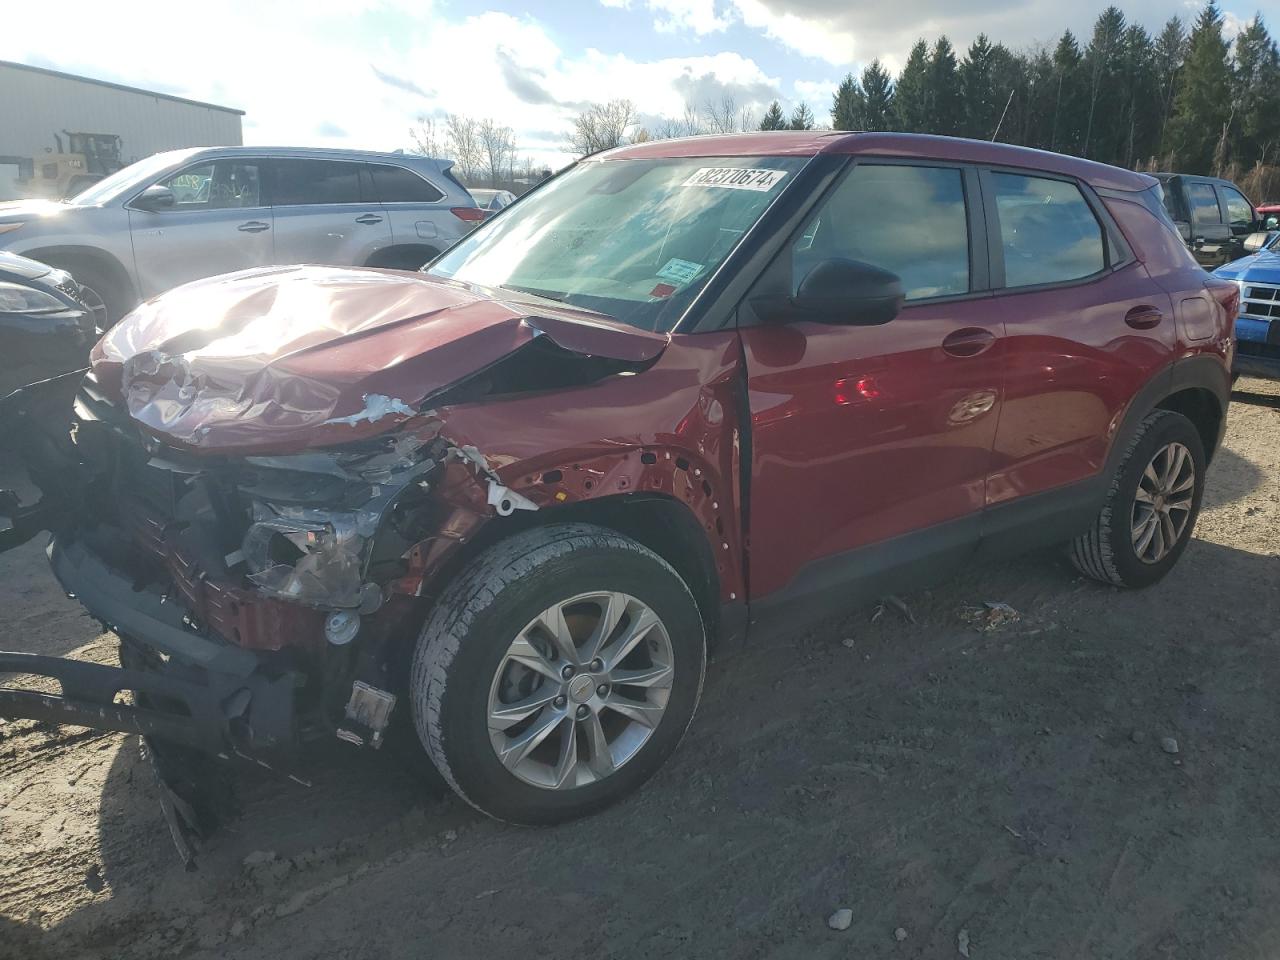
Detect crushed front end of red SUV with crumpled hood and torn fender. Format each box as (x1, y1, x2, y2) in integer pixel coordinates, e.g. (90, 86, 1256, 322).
(0, 268, 744, 844)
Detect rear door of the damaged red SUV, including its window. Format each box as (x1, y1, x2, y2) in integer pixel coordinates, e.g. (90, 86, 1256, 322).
(983, 170, 1175, 522)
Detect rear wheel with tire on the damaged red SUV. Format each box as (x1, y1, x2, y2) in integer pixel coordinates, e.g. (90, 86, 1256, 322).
(1070, 410, 1206, 588)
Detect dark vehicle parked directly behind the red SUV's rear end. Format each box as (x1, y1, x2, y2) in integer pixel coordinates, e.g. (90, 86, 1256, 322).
(1153, 173, 1262, 269)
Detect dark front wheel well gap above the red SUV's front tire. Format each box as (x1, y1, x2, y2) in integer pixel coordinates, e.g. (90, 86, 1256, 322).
(430, 494, 721, 643)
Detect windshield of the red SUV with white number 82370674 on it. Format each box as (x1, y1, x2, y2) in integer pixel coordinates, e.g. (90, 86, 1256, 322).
(429, 156, 806, 332)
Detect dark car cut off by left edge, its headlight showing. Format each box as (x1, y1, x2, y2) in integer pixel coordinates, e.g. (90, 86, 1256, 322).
(0, 251, 99, 397)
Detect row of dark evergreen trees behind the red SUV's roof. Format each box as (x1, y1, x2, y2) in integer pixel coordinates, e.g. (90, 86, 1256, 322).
(760, 0, 1280, 189)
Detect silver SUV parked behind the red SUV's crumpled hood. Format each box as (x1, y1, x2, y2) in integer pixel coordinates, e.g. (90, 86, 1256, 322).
(0, 147, 484, 323)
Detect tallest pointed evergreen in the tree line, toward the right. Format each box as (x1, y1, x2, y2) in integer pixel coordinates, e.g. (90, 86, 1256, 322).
(1169, 0, 1231, 174)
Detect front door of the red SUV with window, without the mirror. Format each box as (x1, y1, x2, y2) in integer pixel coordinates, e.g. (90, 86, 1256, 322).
(741, 163, 1004, 599)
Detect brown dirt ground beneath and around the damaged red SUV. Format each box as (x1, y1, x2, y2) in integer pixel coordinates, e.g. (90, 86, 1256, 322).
(0, 381, 1280, 960)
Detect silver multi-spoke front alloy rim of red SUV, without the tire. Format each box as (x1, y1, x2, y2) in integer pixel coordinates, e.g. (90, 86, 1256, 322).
(488, 591, 675, 790)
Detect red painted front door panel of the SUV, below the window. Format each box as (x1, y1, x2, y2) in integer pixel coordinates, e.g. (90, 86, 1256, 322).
(742, 304, 1004, 596)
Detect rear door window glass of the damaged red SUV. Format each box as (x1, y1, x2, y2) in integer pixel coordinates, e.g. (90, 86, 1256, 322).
(992, 173, 1106, 287)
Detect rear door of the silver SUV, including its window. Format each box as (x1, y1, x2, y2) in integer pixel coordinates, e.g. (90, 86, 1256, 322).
(269, 157, 392, 266)
